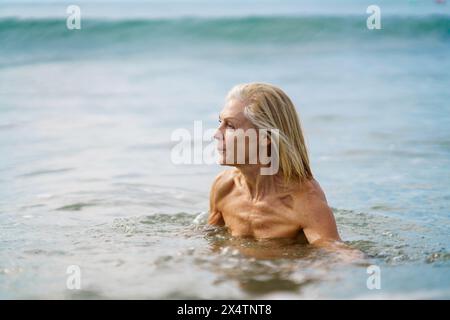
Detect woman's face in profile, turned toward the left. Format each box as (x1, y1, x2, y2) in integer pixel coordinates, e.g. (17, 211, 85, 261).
(214, 99, 270, 167)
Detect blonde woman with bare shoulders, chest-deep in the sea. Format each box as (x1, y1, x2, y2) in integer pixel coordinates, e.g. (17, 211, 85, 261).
(208, 83, 340, 245)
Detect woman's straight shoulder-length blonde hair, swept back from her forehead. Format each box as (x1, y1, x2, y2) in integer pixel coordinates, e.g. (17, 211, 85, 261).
(226, 82, 313, 182)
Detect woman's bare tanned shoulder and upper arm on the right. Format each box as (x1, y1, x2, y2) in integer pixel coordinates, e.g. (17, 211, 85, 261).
(294, 179, 340, 243)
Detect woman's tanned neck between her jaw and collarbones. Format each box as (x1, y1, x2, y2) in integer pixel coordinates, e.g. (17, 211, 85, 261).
(238, 165, 282, 200)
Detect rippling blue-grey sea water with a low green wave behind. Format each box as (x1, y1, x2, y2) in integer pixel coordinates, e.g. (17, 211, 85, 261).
(0, 1, 450, 299)
